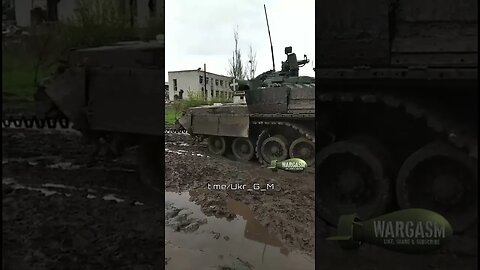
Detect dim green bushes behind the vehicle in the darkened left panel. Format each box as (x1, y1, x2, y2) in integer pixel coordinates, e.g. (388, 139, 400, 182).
(2, 0, 164, 99)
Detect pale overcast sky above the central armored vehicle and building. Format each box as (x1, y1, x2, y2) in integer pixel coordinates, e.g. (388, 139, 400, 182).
(165, 0, 315, 80)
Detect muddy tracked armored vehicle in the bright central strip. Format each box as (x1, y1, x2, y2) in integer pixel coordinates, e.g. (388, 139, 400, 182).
(179, 47, 315, 165)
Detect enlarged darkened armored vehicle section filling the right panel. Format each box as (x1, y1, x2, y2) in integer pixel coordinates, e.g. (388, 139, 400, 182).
(315, 0, 478, 231)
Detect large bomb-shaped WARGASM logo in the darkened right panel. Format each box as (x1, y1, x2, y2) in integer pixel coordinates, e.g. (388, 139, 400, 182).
(327, 208, 453, 253)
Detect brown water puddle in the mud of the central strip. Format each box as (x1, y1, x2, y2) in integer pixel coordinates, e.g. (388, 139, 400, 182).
(165, 192, 315, 270)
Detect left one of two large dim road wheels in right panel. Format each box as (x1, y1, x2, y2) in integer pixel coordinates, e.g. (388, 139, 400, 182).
(315, 136, 394, 225)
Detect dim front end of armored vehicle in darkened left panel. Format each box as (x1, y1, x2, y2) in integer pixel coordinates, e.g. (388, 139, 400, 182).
(33, 40, 165, 188)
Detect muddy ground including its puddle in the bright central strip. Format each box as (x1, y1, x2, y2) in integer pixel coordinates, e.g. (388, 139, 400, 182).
(165, 134, 315, 269)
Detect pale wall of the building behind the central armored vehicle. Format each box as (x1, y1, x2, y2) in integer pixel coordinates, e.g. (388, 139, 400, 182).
(168, 70, 233, 100)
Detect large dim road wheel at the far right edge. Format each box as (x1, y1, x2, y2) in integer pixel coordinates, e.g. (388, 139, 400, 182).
(397, 142, 478, 232)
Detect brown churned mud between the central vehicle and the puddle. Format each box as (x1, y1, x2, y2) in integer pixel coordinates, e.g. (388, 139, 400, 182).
(165, 134, 315, 255)
